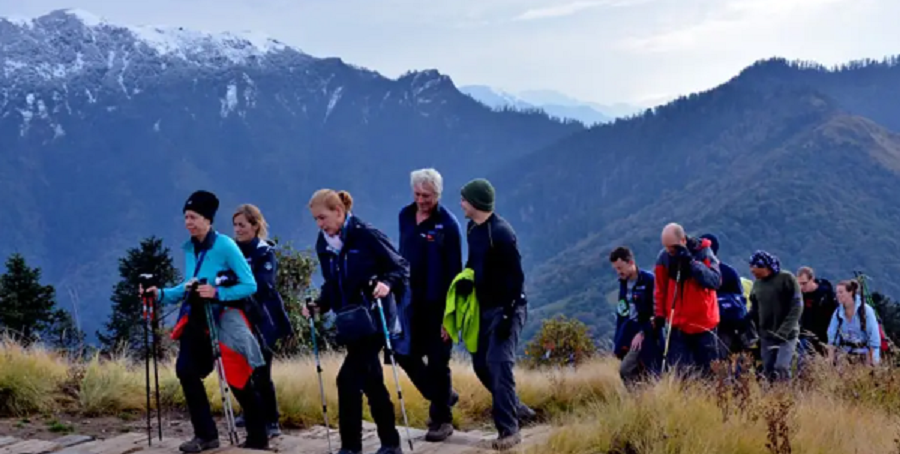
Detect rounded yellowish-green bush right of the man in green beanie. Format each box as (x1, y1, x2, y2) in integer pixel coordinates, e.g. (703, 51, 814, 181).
(525, 315, 597, 367)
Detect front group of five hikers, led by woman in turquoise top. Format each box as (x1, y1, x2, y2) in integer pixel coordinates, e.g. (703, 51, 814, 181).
(139, 169, 536, 454)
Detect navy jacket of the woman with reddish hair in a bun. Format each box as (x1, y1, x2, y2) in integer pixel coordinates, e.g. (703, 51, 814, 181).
(316, 215, 410, 354)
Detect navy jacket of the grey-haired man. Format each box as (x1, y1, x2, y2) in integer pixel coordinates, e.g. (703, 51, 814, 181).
(399, 203, 462, 306)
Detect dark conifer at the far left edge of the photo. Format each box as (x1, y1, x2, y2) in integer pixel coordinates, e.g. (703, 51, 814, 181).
(0, 253, 56, 344)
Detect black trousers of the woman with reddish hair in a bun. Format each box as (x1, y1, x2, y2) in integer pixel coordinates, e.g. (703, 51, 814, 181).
(337, 335, 400, 452)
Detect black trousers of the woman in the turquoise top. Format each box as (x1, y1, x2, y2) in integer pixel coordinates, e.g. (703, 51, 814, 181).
(175, 330, 268, 445)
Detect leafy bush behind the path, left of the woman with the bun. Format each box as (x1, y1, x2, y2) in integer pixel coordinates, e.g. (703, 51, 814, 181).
(273, 238, 335, 355)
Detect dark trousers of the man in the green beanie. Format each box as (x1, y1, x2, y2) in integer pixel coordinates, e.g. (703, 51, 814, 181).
(472, 304, 528, 438)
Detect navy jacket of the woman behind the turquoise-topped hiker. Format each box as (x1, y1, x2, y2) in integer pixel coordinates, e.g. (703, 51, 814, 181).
(238, 238, 294, 347)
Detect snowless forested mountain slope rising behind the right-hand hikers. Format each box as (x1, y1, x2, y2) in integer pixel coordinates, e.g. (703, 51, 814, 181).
(489, 57, 900, 340)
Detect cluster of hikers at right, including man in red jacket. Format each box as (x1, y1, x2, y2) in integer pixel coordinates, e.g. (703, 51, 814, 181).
(609, 223, 889, 385)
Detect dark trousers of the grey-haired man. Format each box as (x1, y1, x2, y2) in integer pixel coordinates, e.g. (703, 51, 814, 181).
(394, 316, 453, 426)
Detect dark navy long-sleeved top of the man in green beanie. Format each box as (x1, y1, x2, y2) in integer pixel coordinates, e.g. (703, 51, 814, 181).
(466, 213, 525, 313)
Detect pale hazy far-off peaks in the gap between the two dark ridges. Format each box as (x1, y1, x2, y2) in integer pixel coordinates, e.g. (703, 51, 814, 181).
(459, 85, 644, 126)
